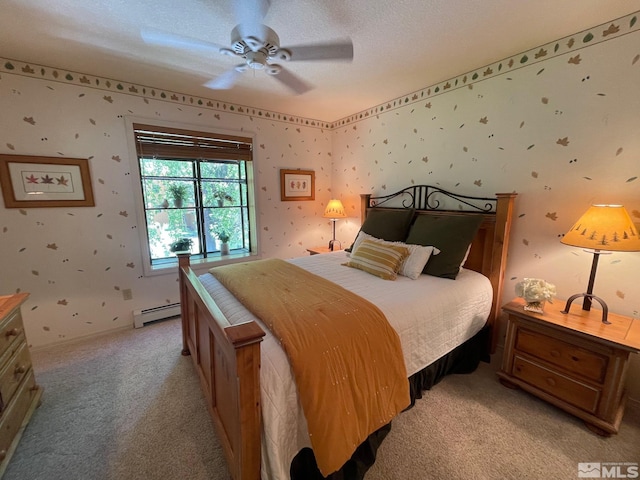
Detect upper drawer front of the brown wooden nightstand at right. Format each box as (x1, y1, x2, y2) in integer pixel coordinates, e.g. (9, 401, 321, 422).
(515, 328, 609, 383)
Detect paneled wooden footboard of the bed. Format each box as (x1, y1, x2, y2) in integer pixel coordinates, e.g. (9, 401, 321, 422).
(178, 254, 265, 480)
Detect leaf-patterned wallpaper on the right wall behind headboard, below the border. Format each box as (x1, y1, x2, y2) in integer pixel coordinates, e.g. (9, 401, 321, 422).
(332, 15, 640, 399)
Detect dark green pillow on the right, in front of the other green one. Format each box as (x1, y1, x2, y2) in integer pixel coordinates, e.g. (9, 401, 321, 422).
(405, 215, 483, 279)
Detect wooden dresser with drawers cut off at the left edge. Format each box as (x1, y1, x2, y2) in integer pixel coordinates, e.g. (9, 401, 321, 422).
(0, 293, 42, 477)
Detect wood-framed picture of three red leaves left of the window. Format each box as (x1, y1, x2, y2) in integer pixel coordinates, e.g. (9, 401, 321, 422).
(0, 155, 95, 208)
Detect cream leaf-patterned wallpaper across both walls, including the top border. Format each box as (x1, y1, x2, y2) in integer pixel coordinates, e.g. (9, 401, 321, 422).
(0, 14, 640, 398)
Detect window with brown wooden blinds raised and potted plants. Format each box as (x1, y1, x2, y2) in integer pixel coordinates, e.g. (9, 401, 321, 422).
(132, 123, 257, 273)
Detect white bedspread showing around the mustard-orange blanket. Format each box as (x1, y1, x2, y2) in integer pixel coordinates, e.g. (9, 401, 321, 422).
(200, 251, 492, 480)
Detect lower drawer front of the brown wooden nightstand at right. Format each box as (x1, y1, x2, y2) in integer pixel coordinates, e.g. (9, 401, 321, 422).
(512, 355, 601, 413)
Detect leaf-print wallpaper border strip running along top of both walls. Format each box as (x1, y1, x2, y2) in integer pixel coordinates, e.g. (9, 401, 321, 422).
(0, 11, 640, 130)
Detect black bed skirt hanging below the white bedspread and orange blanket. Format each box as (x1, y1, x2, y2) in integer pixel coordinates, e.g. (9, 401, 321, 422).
(290, 328, 491, 480)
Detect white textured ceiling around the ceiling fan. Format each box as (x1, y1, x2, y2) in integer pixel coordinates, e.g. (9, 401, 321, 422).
(0, 0, 640, 121)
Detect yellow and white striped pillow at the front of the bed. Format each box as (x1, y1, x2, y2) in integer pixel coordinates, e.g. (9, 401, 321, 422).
(343, 240, 409, 280)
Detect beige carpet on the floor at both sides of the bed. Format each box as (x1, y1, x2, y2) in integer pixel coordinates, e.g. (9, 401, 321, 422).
(3, 320, 640, 480)
